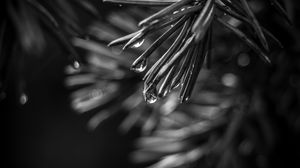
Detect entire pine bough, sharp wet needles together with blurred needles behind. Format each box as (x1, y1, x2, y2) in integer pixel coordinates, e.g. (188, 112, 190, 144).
(1, 0, 291, 168)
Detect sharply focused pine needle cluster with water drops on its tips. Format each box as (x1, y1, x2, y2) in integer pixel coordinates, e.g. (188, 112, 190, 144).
(105, 0, 288, 103)
